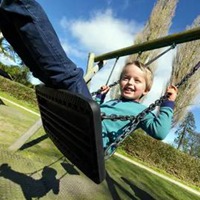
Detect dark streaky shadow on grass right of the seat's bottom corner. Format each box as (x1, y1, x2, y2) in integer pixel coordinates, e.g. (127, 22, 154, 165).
(106, 172, 154, 200)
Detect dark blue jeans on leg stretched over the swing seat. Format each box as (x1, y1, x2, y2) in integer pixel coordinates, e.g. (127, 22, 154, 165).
(0, 0, 91, 98)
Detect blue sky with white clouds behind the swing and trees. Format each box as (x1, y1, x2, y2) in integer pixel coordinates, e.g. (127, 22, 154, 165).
(0, 0, 200, 142)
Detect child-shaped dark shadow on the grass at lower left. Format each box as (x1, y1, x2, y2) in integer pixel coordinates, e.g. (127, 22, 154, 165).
(0, 163, 60, 200)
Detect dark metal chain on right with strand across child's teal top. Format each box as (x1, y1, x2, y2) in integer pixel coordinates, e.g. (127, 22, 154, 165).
(102, 61, 200, 159)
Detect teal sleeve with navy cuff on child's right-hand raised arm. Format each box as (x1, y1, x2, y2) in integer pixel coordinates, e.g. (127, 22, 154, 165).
(139, 101, 174, 140)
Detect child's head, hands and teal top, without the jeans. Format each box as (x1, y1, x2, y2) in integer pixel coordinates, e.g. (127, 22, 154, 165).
(98, 61, 177, 148)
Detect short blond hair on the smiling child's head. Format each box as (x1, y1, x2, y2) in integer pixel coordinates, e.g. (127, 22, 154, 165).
(120, 60, 153, 91)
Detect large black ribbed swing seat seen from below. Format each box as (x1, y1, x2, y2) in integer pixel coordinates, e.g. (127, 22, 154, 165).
(36, 85, 105, 184)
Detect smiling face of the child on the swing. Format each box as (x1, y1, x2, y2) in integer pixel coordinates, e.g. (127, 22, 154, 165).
(120, 64, 148, 101)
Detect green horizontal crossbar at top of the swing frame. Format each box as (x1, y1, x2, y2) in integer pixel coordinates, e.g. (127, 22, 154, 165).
(94, 27, 200, 62)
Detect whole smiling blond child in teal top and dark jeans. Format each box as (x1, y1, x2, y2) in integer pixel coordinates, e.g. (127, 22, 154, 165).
(0, 0, 177, 152)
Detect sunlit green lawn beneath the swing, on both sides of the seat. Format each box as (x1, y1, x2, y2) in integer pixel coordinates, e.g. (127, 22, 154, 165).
(0, 93, 199, 200)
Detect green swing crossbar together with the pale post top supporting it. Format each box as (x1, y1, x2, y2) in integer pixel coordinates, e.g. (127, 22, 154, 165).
(84, 27, 200, 86)
